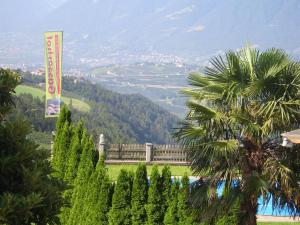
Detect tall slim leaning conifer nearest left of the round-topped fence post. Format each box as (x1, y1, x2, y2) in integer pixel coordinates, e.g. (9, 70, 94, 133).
(67, 134, 94, 225)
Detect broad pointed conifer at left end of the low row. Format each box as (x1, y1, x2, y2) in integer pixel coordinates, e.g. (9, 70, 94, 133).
(109, 169, 131, 225)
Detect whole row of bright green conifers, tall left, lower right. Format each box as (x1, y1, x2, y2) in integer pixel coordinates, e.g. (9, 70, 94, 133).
(52, 107, 200, 225)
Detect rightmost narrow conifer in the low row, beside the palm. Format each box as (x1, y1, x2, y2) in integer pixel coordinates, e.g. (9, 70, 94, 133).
(178, 173, 193, 225)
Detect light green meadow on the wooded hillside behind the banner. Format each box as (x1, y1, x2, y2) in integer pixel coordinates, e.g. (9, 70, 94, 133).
(16, 85, 90, 112)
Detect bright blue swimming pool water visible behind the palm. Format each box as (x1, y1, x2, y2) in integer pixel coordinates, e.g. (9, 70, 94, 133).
(190, 178, 289, 216)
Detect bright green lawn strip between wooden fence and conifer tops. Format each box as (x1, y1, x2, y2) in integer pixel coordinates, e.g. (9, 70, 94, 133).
(106, 164, 192, 180)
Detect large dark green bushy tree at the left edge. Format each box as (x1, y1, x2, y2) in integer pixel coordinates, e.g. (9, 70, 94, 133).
(0, 69, 66, 225)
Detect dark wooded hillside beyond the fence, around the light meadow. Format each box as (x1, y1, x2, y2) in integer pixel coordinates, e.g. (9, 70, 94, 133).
(14, 73, 178, 143)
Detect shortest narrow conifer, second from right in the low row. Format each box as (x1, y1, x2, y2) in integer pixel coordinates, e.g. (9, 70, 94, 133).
(164, 179, 179, 225)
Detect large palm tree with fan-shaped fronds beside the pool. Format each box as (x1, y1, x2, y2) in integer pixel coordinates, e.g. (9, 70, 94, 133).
(176, 47, 300, 225)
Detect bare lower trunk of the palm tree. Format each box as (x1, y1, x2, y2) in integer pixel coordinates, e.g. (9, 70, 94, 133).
(239, 195, 258, 225)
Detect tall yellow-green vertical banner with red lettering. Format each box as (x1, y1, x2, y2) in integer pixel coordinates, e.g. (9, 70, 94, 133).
(44, 31, 63, 117)
